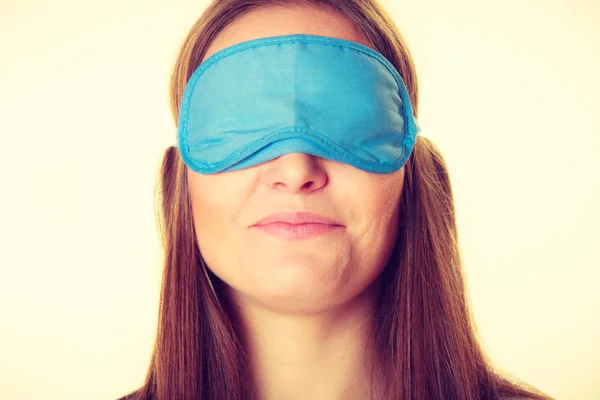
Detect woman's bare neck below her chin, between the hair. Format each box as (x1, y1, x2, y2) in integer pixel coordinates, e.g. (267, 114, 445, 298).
(225, 278, 378, 400)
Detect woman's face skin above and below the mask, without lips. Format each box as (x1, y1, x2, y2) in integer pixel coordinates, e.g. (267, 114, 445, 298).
(187, 7, 404, 313)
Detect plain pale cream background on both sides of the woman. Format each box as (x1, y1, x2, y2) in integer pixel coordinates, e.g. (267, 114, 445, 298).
(0, 0, 600, 400)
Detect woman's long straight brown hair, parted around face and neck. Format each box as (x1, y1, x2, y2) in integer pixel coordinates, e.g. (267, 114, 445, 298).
(122, 0, 550, 400)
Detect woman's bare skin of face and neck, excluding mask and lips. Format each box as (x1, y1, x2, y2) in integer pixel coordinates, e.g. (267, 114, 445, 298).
(187, 6, 404, 400)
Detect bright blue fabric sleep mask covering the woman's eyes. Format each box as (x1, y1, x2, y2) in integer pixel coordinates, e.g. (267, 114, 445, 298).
(177, 34, 420, 174)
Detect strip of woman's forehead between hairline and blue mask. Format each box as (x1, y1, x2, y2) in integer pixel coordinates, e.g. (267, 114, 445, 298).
(204, 5, 373, 59)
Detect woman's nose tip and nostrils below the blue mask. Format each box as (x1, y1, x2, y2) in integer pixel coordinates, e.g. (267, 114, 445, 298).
(262, 153, 328, 193)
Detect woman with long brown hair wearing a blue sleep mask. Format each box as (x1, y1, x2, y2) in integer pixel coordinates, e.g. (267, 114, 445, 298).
(120, 0, 549, 400)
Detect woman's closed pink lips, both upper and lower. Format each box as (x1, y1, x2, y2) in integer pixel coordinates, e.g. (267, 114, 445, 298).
(251, 212, 344, 239)
